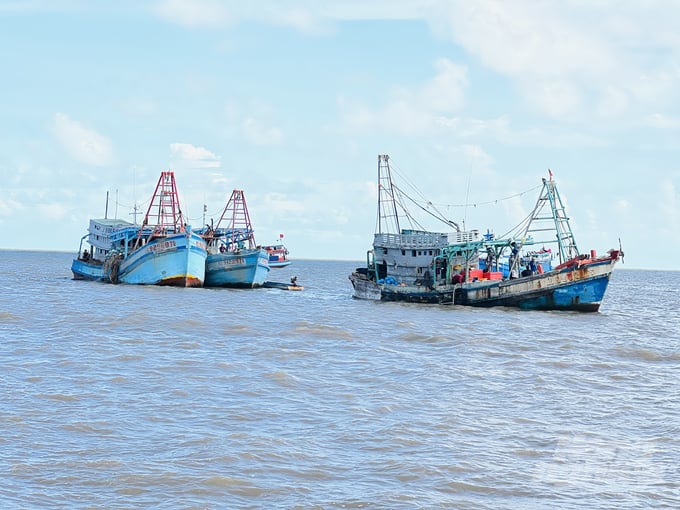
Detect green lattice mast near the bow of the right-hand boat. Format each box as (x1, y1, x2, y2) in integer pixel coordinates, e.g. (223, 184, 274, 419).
(523, 172, 579, 264)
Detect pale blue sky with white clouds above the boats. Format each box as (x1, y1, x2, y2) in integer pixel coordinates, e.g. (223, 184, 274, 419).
(0, 0, 680, 270)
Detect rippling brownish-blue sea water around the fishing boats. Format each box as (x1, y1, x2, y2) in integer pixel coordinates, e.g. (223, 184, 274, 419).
(0, 251, 680, 509)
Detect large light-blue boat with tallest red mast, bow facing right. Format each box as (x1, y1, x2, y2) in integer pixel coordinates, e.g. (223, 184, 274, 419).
(103, 171, 207, 287)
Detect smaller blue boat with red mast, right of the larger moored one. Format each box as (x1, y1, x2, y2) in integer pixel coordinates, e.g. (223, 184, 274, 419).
(201, 189, 269, 288)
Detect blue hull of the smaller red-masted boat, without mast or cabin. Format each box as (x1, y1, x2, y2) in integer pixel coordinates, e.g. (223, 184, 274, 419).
(204, 249, 269, 288)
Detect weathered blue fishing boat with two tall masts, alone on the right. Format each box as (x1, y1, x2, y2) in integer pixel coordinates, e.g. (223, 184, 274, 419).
(349, 155, 623, 312)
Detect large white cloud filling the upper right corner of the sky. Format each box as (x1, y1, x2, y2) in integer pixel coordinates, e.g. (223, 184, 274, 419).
(424, 0, 680, 121)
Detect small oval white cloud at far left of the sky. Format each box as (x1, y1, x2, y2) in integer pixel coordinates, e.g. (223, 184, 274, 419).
(53, 113, 113, 166)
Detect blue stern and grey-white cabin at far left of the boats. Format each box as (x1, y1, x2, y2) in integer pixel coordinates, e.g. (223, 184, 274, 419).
(71, 217, 133, 281)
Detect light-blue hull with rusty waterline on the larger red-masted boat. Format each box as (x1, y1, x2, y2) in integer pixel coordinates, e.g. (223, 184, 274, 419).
(109, 232, 207, 287)
